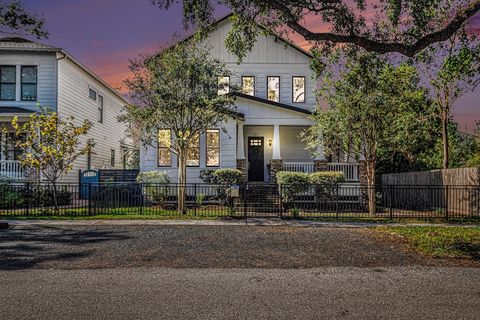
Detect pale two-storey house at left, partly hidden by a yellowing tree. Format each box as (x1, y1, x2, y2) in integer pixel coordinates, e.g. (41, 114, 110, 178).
(0, 38, 129, 182)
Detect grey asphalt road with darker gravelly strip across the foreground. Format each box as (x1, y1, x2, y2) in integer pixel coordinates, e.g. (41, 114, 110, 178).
(0, 226, 480, 319)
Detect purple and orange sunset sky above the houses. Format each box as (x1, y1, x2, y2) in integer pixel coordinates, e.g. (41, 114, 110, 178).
(23, 0, 480, 132)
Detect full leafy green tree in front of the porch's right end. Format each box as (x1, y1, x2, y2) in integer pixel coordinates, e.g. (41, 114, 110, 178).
(305, 52, 434, 214)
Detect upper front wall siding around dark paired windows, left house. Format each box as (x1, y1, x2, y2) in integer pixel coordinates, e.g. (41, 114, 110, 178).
(0, 51, 57, 111)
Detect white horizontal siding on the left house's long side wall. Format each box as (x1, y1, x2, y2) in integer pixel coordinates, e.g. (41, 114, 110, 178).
(58, 59, 126, 182)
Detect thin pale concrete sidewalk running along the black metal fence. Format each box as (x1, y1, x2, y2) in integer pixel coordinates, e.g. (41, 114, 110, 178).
(0, 218, 479, 228)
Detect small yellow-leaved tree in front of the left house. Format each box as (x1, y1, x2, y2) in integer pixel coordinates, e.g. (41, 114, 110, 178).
(12, 108, 94, 211)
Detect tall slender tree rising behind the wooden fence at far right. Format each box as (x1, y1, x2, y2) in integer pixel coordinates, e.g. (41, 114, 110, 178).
(417, 29, 480, 169)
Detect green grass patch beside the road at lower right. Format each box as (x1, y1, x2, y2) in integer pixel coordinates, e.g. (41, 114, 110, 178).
(375, 226, 480, 260)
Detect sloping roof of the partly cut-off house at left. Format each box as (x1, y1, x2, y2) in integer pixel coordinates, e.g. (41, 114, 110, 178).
(0, 37, 129, 104)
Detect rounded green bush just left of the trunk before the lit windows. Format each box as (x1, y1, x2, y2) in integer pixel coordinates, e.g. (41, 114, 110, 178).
(137, 171, 170, 205)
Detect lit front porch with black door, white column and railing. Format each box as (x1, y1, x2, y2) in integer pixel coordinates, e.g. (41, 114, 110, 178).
(237, 122, 359, 183)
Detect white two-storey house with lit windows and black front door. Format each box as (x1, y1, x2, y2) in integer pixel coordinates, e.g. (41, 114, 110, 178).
(140, 16, 358, 183)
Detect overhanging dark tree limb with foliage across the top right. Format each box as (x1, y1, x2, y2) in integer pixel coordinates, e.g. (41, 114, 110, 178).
(152, 0, 480, 57)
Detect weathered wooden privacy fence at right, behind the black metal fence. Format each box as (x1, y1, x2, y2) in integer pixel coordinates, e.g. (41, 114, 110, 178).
(382, 168, 480, 214)
